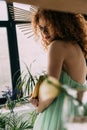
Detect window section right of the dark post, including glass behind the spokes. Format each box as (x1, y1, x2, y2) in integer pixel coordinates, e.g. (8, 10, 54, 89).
(14, 3, 47, 74)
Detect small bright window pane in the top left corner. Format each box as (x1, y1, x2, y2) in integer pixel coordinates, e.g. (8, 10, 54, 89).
(0, 0, 8, 21)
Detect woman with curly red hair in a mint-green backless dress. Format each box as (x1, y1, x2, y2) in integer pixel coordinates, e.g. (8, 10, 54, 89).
(31, 8, 87, 130)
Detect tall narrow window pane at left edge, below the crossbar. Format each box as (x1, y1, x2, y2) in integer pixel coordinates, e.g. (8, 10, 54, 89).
(0, 28, 12, 98)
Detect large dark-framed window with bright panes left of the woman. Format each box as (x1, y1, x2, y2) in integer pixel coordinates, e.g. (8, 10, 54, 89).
(0, 0, 47, 100)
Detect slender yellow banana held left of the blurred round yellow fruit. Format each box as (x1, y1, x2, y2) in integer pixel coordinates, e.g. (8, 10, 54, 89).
(32, 75, 47, 98)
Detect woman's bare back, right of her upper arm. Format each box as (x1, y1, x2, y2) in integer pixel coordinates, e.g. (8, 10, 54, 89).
(64, 43, 86, 83)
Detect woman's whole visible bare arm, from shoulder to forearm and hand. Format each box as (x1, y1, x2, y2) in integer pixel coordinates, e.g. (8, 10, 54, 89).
(37, 41, 65, 112)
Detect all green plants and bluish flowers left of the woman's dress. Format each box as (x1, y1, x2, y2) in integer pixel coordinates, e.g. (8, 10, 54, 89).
(0, 65, 44, 130)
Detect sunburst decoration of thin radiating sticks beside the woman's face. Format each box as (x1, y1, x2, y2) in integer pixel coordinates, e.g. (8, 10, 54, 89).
(8, 5, 36, 38)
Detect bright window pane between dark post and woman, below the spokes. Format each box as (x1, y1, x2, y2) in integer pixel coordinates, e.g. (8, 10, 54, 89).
(16, 26, 47, 74)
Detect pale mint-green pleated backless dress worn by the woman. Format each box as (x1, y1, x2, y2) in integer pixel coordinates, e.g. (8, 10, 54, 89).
(33, 71, 87, 130)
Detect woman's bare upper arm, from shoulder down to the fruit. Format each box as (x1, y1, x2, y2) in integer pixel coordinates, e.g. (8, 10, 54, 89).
(47, 41, 66, 80)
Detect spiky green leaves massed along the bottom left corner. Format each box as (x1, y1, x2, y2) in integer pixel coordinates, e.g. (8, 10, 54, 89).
(0, 111, 37, 130)
